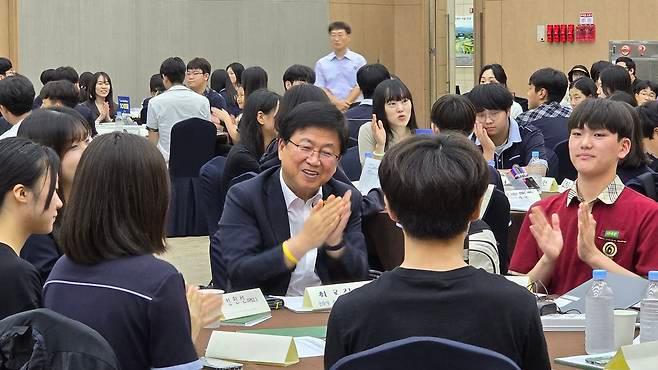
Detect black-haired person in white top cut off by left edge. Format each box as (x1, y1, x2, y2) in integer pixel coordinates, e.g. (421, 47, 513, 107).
(0, 75, 34, 139)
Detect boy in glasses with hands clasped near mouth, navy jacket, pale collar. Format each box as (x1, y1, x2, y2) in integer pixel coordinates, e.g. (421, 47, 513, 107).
(467, 84, 548, 169)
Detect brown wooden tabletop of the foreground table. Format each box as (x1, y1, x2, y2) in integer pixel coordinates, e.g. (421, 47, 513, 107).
(197, 308, 585, 370)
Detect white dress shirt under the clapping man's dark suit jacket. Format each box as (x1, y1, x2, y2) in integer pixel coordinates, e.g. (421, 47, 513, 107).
(279, 171, 322, 296)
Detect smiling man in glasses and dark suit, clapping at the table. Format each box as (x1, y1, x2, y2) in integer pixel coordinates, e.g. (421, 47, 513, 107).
(215, 102, 368, 295)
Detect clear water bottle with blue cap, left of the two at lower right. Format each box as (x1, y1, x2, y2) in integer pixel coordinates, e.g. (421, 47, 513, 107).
(585, 270, 615, 355)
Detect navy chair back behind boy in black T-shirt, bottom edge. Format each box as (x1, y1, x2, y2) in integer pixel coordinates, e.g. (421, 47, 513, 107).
(331, 337, 520, 370)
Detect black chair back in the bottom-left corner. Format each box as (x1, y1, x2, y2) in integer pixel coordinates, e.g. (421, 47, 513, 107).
(0, 308, 120, 370)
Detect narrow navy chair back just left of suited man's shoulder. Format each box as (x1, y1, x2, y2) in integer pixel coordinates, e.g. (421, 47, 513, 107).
(199, 157, 226, 237)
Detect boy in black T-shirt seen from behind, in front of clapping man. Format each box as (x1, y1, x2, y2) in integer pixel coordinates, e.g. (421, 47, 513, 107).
(324, 133, 550, 370)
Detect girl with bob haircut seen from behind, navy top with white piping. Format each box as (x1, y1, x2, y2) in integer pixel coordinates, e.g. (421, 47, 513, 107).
(43, 132, 217, 369)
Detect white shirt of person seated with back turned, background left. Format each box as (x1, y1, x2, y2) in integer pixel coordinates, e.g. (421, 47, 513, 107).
(146, 85, 210, 163)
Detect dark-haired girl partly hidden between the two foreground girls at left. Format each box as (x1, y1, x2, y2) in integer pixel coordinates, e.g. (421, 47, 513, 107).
(18, 108, 91, 281)
